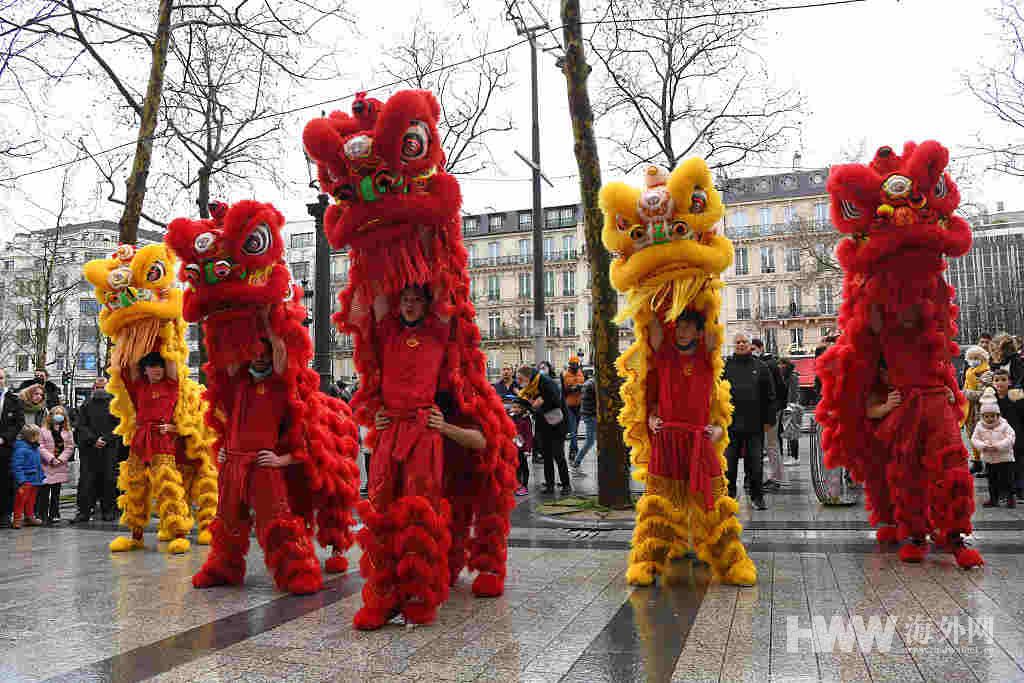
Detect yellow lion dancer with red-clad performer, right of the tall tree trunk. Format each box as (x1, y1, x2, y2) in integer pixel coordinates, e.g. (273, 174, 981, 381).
(599, 159, 757, 586)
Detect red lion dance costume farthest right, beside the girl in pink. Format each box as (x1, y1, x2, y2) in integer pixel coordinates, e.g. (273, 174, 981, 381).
(816, 140, 982, 568)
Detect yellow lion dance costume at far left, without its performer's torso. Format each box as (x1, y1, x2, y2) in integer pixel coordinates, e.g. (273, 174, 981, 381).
(83, 245, 217, 553)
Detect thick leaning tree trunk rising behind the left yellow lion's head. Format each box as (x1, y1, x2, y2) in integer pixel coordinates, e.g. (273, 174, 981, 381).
(119, 0, 173, 245)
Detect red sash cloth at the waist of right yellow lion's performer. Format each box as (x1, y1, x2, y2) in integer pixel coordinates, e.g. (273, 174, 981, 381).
(651, 422, 722, 510)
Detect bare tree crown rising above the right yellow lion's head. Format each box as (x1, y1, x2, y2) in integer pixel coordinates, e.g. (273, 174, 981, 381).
(591, 0, 803, 172)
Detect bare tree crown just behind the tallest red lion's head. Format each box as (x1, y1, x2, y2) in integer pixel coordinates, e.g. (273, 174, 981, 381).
(382, 13, 513, 175)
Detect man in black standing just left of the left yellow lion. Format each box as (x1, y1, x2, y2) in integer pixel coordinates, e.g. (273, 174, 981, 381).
(73, 377, 121, 523)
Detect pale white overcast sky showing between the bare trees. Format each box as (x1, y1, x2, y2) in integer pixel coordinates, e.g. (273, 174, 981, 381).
(0, 0, 1024, 238)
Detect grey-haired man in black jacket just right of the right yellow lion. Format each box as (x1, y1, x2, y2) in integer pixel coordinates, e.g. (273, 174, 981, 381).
(722, 333, 775, 510)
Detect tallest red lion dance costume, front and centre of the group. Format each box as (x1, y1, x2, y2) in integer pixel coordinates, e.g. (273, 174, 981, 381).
(303, 90, 517, 629)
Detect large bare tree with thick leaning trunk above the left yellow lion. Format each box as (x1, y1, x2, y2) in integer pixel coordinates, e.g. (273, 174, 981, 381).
(0, 0, 345, 243)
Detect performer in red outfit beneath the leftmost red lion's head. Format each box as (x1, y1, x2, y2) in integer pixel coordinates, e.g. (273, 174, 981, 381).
(193, 327, 323, 594)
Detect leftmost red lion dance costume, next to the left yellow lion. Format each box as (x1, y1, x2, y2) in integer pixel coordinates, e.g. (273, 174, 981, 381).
(165, 201, 358, 593)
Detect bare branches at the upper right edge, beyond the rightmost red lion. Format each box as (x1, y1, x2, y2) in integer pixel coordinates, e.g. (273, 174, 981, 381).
(964, 0, 1024, 176)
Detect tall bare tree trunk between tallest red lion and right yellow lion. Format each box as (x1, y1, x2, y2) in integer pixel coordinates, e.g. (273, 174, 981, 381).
(561, 0, 632, 508)
